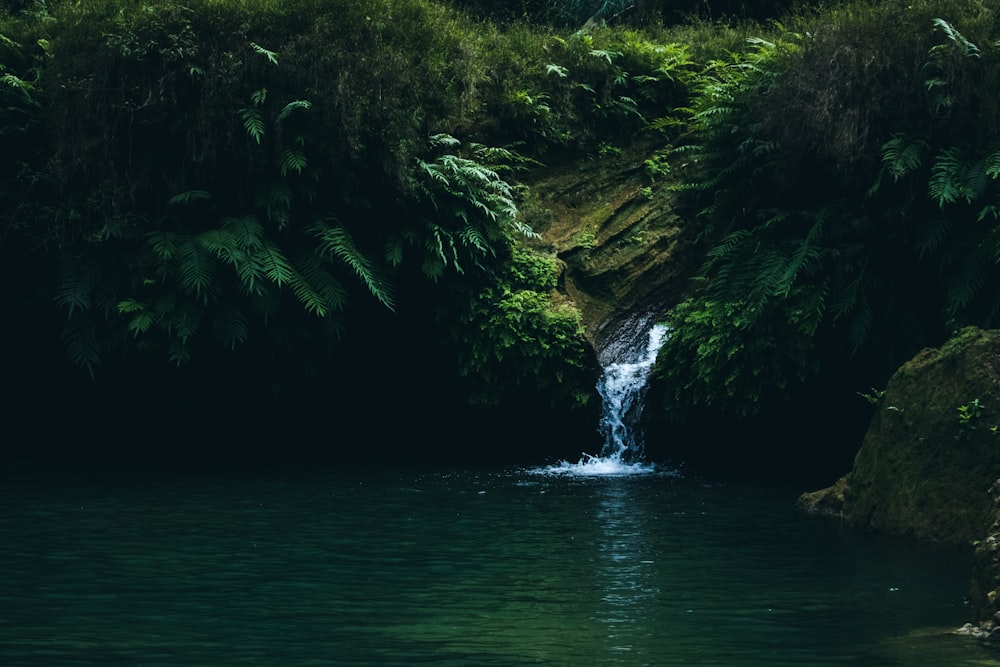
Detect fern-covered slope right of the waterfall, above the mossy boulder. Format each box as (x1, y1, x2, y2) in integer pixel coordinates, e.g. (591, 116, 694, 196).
(661, 0, 1000, 414)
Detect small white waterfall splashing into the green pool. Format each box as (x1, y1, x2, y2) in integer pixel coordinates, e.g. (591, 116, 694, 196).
(543, 324, 667, 475)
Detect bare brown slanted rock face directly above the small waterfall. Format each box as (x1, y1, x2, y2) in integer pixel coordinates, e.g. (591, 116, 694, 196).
(522, 146, 701, 361)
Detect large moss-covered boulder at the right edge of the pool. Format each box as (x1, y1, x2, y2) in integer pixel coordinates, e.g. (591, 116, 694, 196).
(800, 328, 1000, 545)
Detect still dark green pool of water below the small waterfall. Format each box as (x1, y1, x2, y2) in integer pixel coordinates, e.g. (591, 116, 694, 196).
(0, 468, 997, 667)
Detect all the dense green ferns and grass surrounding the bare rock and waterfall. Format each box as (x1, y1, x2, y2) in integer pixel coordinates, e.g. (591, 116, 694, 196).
(0, 0, 1000, 470)
